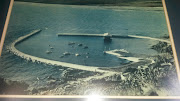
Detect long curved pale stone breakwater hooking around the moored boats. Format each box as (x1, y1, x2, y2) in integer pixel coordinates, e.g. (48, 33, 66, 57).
(8, 29, 109, 72)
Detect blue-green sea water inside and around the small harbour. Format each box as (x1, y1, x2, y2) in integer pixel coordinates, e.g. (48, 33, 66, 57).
(0, 1, 168, 86)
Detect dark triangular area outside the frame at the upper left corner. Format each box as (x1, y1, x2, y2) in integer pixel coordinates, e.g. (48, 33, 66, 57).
(0, 0, 10, 38)
